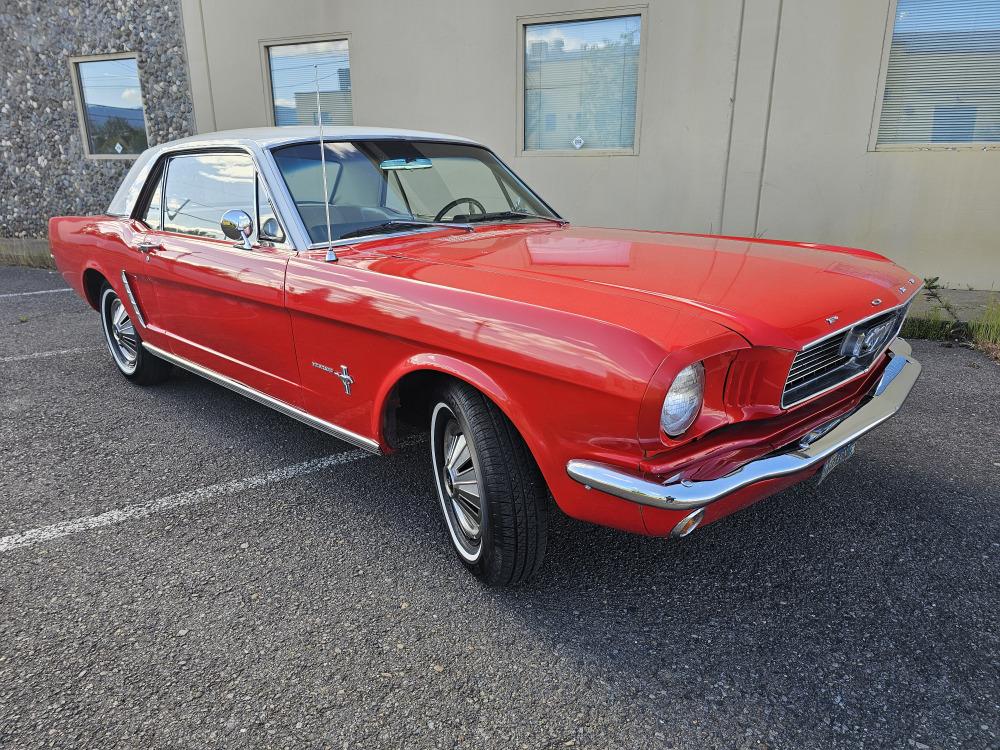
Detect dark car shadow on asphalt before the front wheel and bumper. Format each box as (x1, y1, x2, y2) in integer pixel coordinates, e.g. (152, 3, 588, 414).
(368, 441, 996, 747)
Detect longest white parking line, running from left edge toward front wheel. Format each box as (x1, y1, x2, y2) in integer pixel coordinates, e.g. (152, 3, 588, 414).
(0, 450, 373, 552)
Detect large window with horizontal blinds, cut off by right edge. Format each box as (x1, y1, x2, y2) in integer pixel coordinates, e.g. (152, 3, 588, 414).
(875, 0, 1000, 148)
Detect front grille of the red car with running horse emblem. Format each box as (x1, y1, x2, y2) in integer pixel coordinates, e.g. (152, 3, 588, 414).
(781, 303, 909, 409)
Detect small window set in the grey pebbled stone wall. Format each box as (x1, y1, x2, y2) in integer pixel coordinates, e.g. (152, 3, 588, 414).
(70, 55, 148, 158)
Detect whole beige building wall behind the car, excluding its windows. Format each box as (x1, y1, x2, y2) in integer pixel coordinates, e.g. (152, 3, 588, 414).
(183, 0, 1000, 288)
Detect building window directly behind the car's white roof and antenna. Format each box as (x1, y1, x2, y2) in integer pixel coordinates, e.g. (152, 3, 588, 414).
(266, 39, 354, 125)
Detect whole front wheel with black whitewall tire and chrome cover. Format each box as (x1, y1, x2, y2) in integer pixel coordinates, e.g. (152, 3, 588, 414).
(431, 383, 548, 586)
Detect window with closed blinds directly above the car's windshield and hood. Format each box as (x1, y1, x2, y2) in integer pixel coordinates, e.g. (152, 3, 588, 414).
(520, 11, 642, 154)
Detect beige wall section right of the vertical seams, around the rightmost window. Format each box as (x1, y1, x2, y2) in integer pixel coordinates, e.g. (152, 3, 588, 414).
(757, 0, 1000, 289)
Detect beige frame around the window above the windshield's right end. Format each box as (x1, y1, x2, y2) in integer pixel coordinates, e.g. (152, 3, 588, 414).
(515, 4, 649, 157)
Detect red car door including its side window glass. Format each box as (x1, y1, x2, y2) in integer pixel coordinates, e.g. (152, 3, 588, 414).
(145, 150, 300, 405)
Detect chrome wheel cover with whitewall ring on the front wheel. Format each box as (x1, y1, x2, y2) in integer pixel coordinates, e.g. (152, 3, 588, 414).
(431, 403, 483, 563)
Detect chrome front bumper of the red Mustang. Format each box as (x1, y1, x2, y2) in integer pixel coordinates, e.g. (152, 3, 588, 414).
(566, 339, 921, 510)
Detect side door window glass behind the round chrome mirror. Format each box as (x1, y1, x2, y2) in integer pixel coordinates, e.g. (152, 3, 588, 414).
(163, 153, 256, 240)
